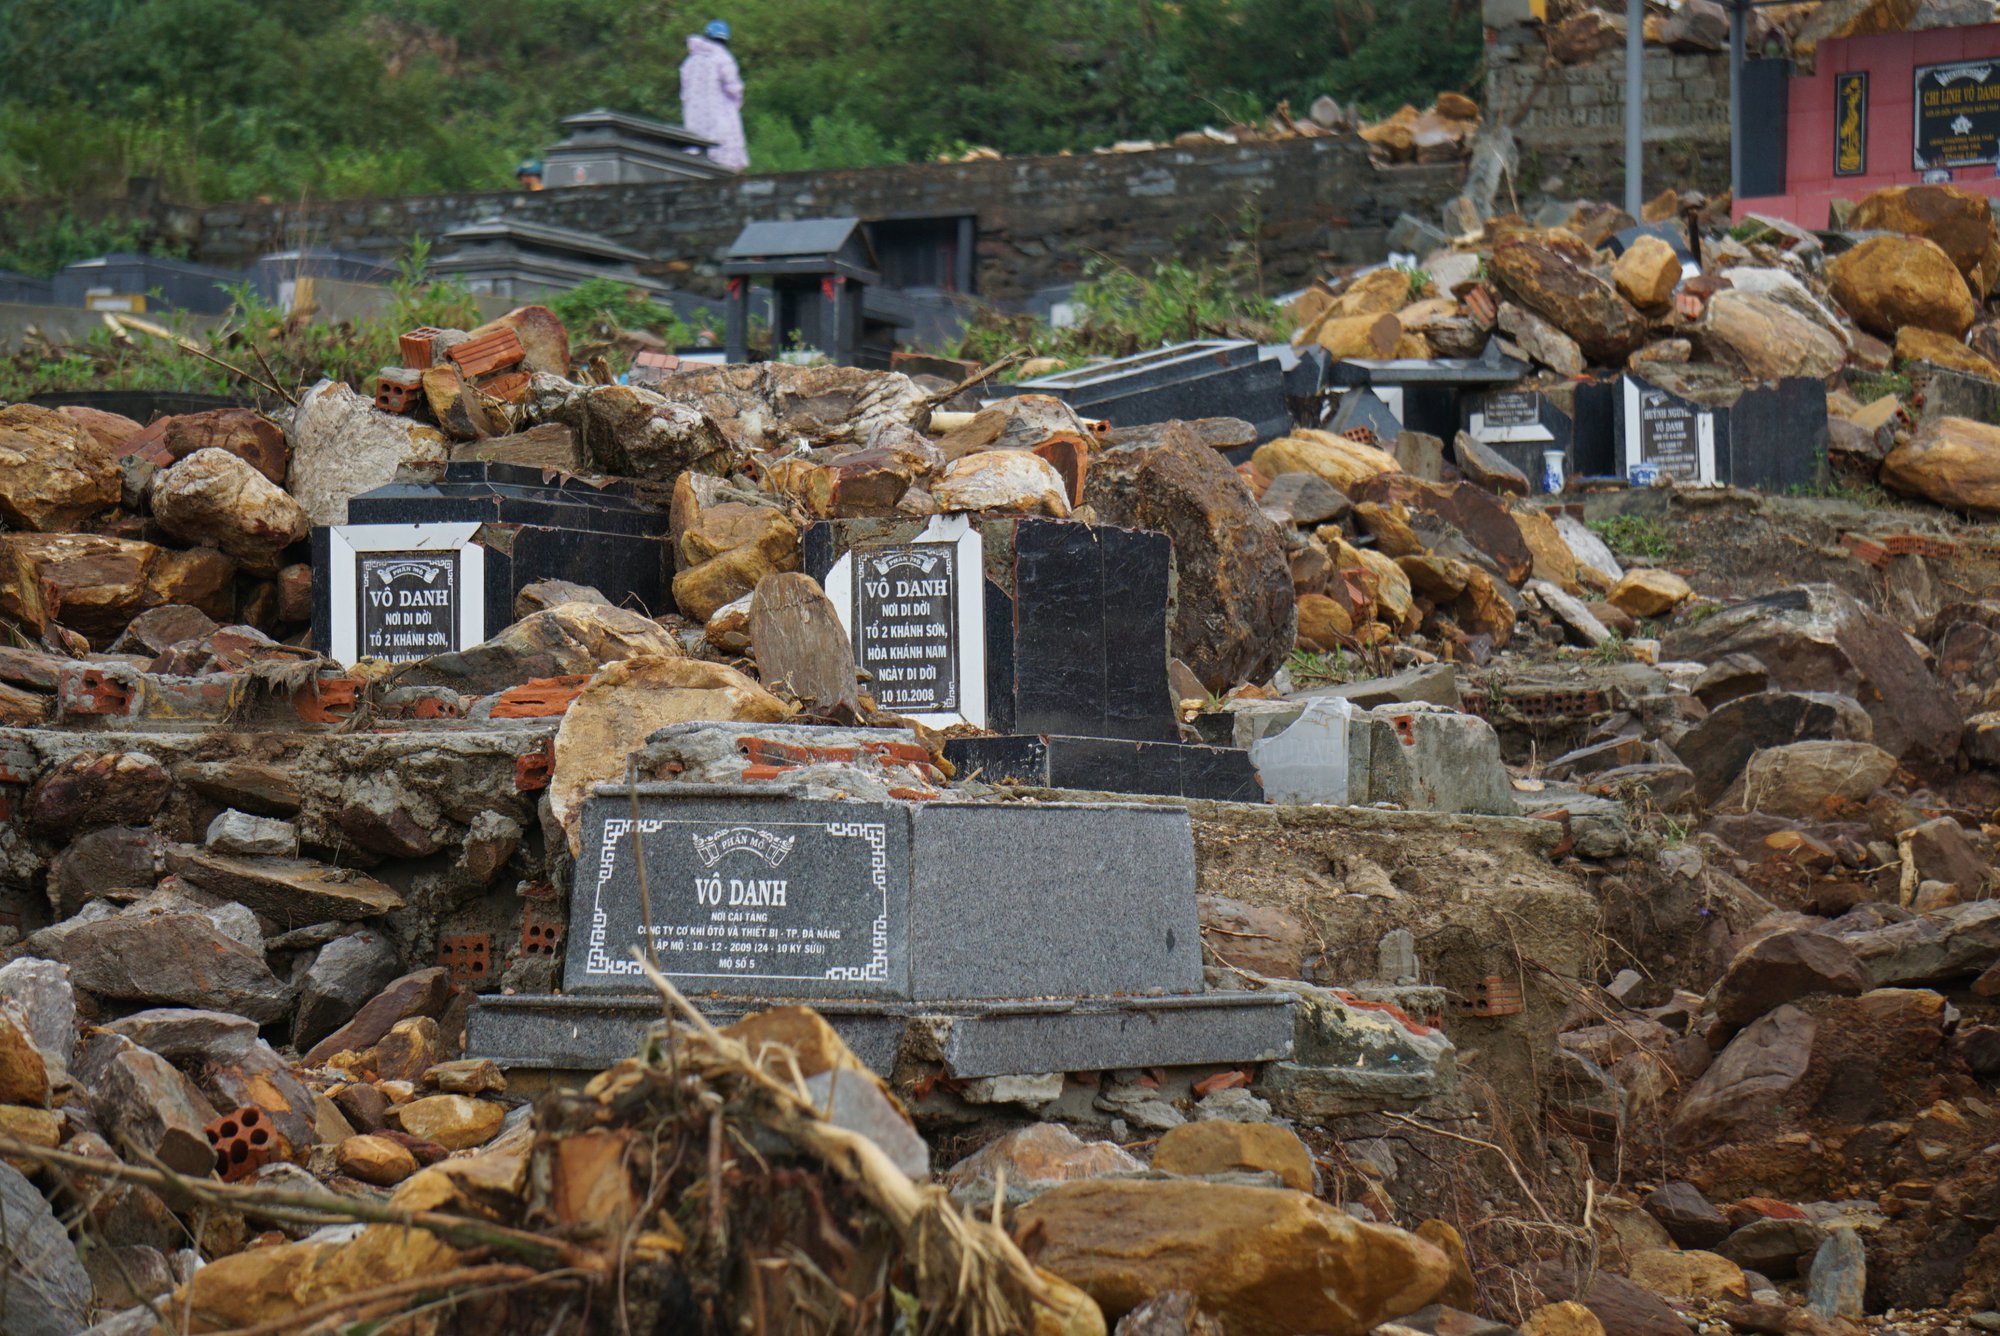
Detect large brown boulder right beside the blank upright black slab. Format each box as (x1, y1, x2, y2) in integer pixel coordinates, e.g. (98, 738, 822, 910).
(1084, 422, 1296, 690)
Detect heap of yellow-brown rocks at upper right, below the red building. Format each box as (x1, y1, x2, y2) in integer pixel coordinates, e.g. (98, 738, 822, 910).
(1288, 177, 2000, 512)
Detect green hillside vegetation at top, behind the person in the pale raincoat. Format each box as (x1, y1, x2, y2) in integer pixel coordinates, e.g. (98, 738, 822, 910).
(0, 0, 1482, 209)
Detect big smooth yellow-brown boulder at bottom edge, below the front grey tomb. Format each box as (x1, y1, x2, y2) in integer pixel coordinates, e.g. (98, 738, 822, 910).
(1014, 1180, 1452, 1336)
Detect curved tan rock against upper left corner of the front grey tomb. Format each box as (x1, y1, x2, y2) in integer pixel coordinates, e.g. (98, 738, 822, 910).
(548, 656, 790, 850)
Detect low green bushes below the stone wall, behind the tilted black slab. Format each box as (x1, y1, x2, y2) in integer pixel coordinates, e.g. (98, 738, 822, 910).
(958, 246, 1284, 364)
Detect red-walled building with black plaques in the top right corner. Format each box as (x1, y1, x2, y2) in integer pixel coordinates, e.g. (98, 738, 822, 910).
(1736, 24, 2000, 228)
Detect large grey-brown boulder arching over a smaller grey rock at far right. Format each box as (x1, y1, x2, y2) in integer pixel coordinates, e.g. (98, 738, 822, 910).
(1668, 584, 1964, 760)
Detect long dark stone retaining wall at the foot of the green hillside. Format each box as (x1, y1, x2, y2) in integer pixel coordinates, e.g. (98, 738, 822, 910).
(184, 138, 1464, 298)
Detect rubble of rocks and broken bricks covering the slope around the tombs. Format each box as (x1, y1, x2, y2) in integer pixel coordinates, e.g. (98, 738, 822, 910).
(0, 167, 2000, 1336)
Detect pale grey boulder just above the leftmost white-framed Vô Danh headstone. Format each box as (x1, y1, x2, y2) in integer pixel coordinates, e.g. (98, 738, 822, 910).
(286, 380, 448, 524)
